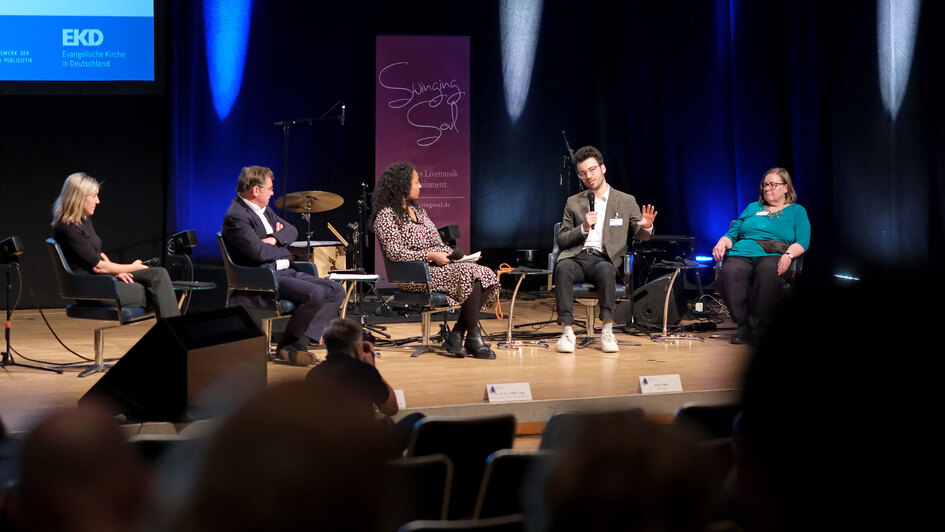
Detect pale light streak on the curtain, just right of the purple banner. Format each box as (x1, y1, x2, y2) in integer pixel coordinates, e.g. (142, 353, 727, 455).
(499, 0, 544, 122)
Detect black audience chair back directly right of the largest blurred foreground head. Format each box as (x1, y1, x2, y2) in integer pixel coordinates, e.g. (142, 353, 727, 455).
(387, 454, 453, 525)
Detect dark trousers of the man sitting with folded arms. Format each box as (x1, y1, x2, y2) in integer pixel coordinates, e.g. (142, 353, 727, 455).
(276, 269, 345, 342)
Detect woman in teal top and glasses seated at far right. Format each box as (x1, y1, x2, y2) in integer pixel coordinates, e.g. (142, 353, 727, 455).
(712, 168, 810, 344)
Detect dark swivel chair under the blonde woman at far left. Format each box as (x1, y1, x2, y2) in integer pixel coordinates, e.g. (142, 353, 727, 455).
(46, 238, 154, 377)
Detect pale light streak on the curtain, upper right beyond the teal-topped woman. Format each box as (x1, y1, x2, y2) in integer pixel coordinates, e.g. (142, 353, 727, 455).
(876, 0, 922, 120)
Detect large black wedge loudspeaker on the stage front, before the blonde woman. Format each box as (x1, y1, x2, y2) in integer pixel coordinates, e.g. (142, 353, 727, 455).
(79, 307, 268, 422)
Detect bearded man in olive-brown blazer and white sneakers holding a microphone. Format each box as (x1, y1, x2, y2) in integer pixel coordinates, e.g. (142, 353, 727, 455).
(554, 146, 656, 353)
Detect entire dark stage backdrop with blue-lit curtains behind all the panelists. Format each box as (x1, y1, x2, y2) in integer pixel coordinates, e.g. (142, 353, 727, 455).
(7, 0, 945, 303)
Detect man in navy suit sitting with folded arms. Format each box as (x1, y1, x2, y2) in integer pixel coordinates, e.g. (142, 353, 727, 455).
(222, 166, 344, 366)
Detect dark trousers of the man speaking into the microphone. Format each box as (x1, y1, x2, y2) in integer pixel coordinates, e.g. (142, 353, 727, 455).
(554, 251, 617, 327)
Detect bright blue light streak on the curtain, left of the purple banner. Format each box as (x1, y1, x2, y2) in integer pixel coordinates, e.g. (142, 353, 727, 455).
(203, 0, 253, 121)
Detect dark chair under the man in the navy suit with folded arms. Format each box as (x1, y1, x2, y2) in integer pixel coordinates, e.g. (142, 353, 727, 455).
(217, 233, 318, 355)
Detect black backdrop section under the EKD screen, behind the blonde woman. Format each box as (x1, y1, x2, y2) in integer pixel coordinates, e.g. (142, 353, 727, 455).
(0, 96, 170, 306)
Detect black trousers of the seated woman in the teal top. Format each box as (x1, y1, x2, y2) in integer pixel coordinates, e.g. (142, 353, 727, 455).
(718, 255, 785, 325)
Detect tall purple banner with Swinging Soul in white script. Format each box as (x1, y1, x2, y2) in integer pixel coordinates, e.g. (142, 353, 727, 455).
(374, 35, 475, 273)
